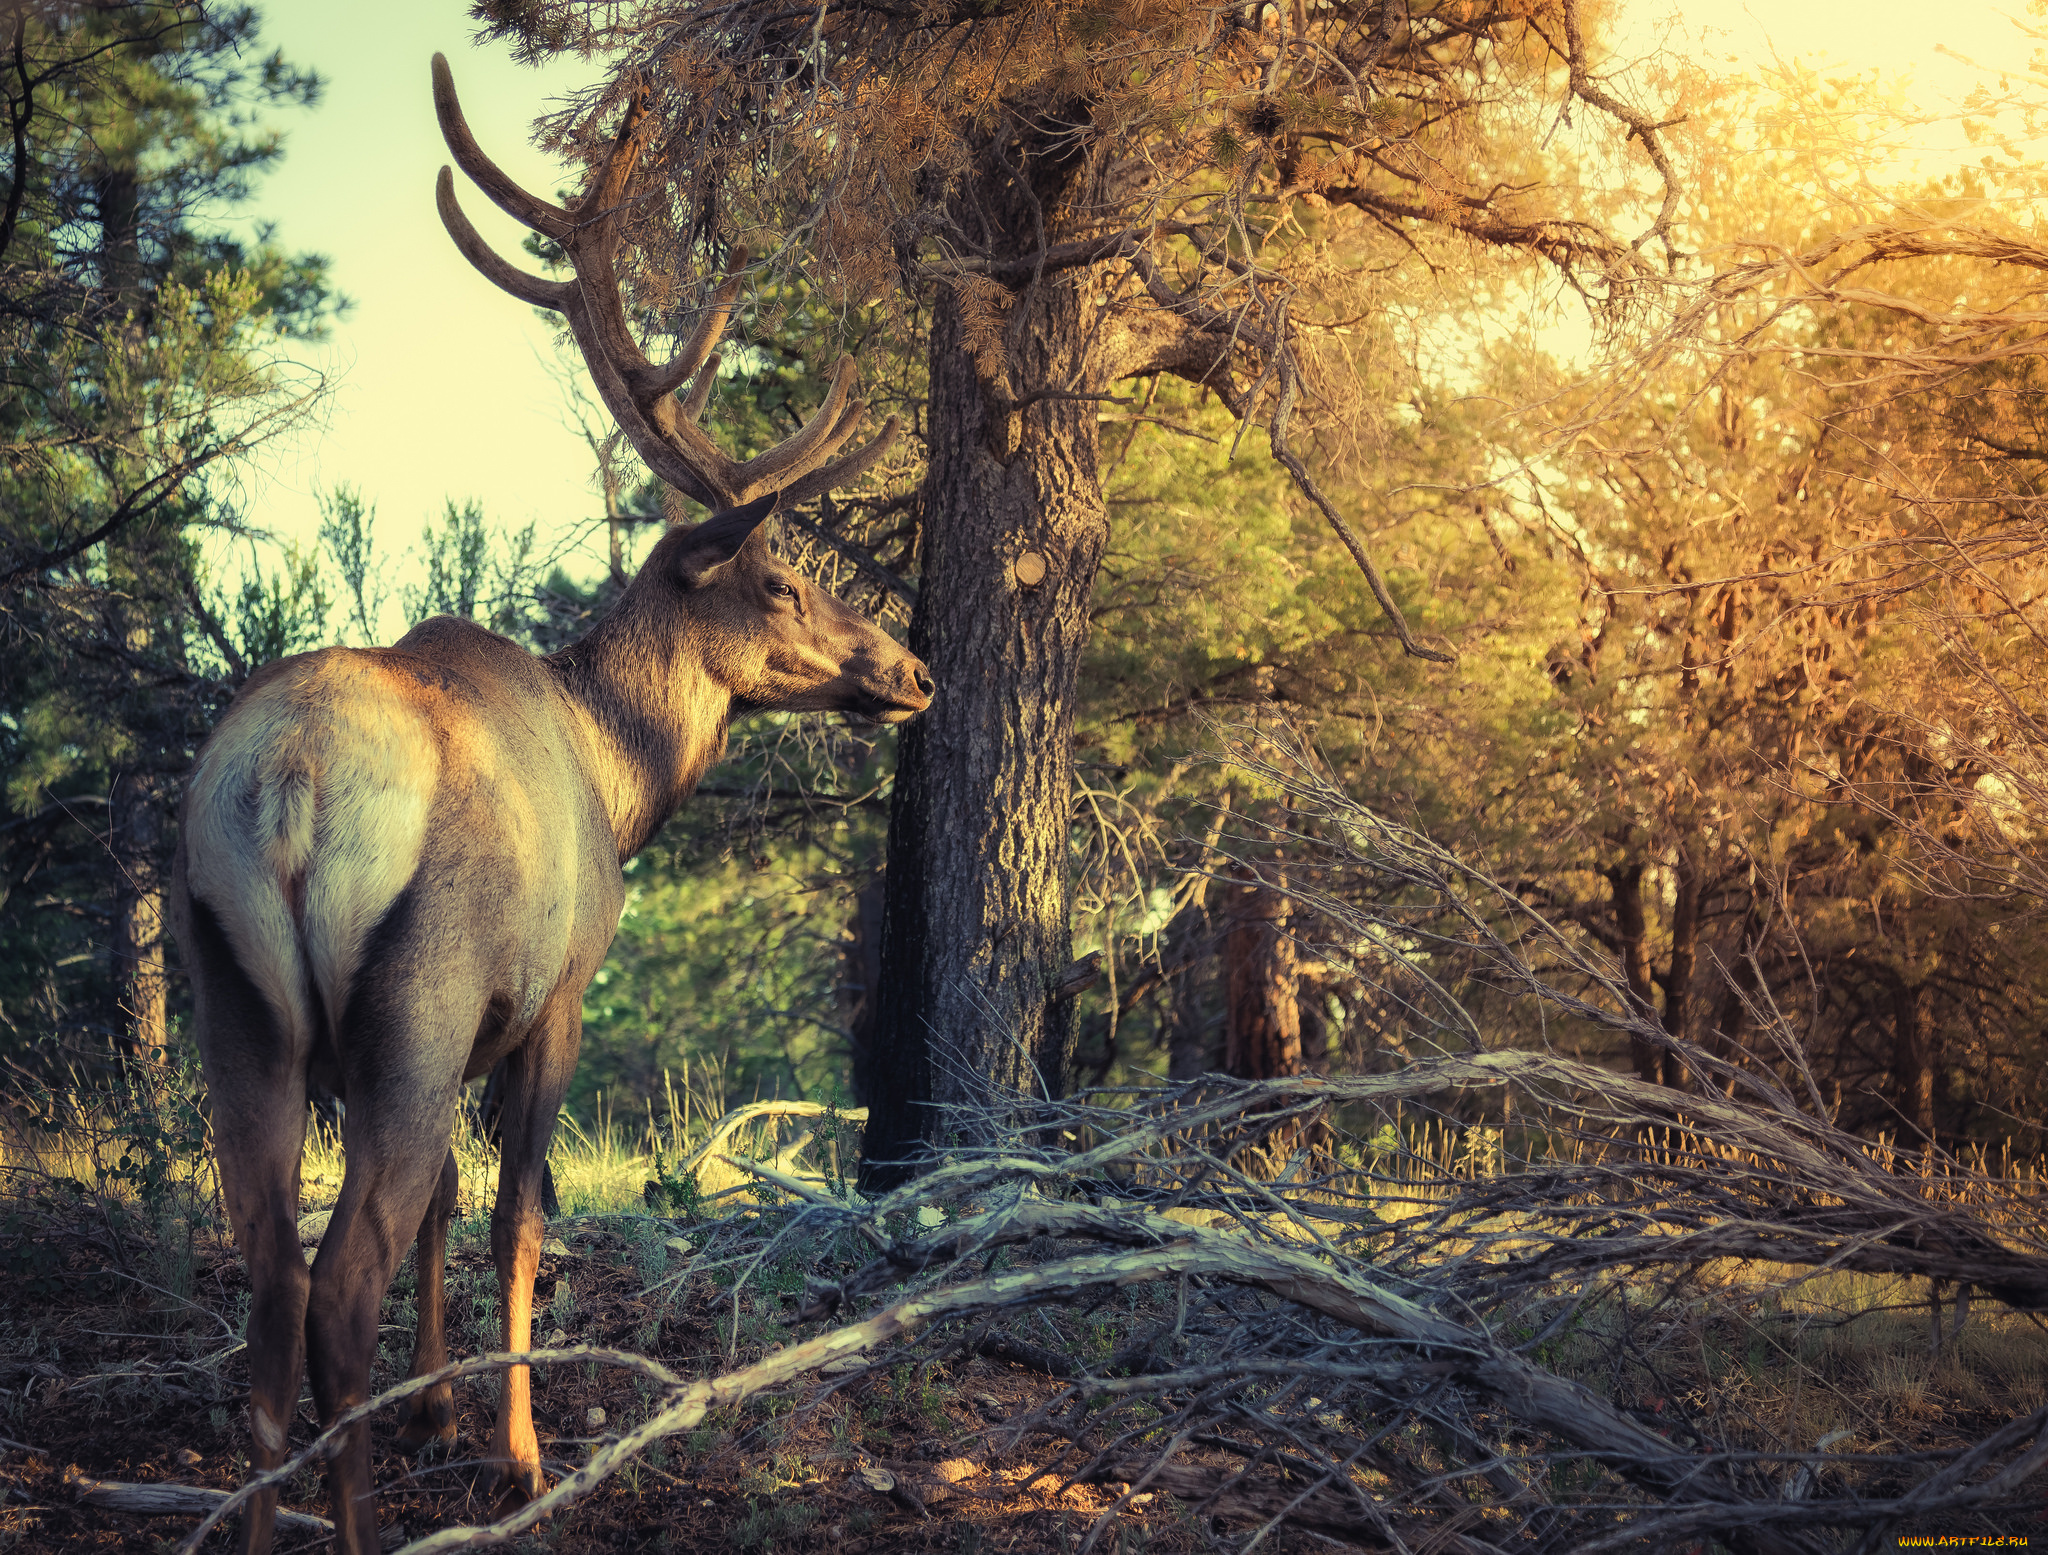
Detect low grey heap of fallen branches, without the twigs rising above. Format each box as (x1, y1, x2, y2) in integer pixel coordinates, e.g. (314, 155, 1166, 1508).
(172, 1053, 2048, 1555)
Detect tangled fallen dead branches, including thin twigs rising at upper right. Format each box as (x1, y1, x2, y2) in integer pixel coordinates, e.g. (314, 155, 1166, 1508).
(172, 737, 2048, 1555)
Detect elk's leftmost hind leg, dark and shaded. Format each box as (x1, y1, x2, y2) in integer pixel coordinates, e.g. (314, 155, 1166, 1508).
(184, 899, 309, 1555)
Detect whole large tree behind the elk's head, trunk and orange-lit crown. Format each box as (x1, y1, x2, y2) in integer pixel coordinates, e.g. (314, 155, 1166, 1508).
(481, 2, 1703, 1176)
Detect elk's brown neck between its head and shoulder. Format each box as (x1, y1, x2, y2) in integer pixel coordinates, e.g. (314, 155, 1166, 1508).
(549, 588, 733, 863)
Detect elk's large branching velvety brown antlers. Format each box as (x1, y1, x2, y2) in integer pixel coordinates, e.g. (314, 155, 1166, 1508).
(434, 53, 897, 510)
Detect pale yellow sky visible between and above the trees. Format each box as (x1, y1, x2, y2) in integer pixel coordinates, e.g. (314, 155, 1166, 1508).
(246, 0, 2030, 631)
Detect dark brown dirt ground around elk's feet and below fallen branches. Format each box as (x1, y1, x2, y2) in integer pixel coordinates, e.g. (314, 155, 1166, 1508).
(0, 1225, 1337, 1555)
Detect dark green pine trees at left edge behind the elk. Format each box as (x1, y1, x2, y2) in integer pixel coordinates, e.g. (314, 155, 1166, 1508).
(0, 2, 332, 1073)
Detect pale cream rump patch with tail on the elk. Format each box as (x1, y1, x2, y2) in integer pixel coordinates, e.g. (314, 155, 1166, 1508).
(186, 647, 440, 1045)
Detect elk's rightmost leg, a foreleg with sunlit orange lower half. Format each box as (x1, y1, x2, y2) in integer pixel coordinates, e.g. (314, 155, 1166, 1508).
(479, 987, 584, 1502)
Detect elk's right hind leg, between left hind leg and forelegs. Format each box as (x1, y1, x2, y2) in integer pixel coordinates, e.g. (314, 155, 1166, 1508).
(305, 975, 483, 1555)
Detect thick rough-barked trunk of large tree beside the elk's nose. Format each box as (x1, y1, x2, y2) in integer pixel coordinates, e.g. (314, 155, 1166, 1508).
(862, 170, 1108, 1186)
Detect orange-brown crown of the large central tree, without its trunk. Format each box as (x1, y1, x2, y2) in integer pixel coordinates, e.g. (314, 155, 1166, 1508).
(456, 0, 1677, 651)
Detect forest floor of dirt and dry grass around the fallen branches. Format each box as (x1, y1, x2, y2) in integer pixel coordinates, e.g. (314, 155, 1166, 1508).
(0, 1098, 2048, 1555)
